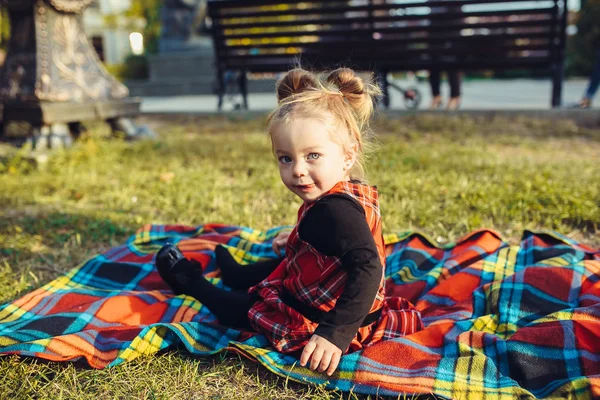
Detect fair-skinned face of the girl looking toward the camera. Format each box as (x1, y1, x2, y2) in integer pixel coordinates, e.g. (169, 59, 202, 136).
(271, 118, 356, 202)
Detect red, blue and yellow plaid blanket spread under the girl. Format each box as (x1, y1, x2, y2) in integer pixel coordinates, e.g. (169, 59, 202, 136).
(0, 224, 600, 399)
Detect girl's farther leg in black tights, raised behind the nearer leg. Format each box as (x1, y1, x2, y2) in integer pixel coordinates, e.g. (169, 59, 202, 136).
(215, 245, 283, 290)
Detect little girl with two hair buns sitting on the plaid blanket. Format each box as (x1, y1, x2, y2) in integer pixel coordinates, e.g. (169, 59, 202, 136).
(156, 68, 422, 375)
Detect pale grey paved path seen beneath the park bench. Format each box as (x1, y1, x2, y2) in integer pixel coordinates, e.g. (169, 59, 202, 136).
(142, 79, 600, 113)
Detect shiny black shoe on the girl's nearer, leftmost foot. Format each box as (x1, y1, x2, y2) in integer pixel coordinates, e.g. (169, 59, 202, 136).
(156, 243, 202, 294)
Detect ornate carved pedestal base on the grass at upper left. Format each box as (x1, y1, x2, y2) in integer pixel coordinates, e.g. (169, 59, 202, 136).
(0, 0, 151, 147)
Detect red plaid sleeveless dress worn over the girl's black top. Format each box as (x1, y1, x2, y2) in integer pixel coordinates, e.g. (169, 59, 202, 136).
(248, 182, 423, 352)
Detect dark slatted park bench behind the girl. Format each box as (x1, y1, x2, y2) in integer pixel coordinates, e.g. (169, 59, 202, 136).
(208, 0, 567, 110)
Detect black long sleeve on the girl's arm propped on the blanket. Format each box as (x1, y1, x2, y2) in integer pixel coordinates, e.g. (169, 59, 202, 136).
(298, 194, 383, 352)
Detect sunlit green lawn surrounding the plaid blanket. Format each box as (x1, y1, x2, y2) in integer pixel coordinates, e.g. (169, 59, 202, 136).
(0, 116, 600, 399)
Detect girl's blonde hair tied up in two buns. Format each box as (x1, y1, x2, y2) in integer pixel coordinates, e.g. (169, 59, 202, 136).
(267, 68, 381, 180)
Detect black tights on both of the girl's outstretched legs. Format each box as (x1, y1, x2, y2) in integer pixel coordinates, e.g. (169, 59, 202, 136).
(173, 246, 282, 329)
